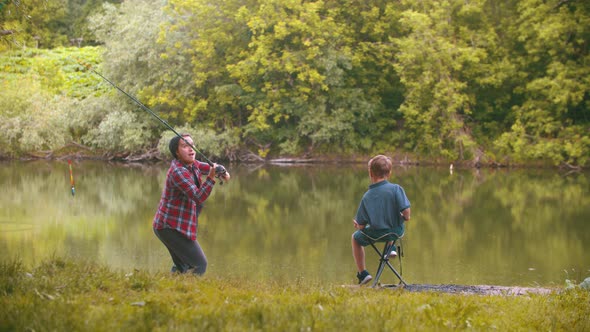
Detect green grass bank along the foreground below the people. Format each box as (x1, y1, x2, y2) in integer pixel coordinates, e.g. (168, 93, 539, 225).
(0, 258, 590, 331)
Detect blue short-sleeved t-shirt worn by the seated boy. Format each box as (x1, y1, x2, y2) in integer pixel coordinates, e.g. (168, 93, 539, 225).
(355, 180, 410, 234)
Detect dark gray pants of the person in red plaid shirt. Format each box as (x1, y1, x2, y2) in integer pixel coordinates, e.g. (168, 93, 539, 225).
(154, 228, 207, 275)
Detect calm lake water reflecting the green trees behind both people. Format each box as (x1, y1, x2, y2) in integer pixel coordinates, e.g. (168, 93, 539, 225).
(0, 161, 590, 286)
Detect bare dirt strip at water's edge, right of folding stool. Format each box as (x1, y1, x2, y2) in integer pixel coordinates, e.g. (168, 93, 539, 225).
(381, 284, 558, 295)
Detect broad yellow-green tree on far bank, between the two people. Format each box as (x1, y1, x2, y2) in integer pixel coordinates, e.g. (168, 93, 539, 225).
(162, 0, 402, 153)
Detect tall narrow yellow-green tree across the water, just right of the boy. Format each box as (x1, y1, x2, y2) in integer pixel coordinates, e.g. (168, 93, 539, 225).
(394, 1, 487, 160)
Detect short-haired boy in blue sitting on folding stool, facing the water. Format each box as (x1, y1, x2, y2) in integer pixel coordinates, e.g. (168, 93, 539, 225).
(352, 155, 410, 285)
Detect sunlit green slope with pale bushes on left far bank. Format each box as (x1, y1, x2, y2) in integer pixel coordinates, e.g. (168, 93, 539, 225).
(0, 48, 157, 156)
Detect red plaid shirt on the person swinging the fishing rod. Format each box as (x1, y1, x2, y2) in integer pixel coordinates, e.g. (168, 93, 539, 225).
(153, 159, 215, 241)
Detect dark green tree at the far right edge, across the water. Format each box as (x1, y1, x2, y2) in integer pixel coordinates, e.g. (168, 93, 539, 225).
(497, 0, 590, 165)
